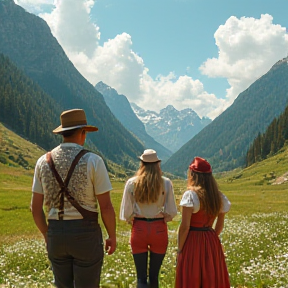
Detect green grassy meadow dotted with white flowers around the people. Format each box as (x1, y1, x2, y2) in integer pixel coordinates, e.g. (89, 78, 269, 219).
(0, 137, 288, 288)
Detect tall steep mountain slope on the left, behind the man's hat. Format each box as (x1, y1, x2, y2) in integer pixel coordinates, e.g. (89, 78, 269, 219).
(0, 0, 144, 166)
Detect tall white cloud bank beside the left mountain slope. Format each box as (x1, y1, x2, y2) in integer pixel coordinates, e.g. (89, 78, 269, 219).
(41, 0, 145, 102)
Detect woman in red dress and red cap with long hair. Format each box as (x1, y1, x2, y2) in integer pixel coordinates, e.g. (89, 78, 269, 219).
(175, 157, 231, 288)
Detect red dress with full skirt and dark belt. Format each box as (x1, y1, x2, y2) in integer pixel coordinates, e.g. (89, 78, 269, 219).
(175, 209, 230, 288)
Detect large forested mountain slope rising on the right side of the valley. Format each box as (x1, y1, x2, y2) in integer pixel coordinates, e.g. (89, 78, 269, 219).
(162, 58, 288, 176)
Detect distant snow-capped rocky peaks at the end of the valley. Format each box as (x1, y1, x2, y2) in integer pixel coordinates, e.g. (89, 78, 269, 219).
(131, 103, 212, 152)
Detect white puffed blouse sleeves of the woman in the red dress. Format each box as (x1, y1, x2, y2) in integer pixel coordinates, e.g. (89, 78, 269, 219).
(180, 190, 231, 213)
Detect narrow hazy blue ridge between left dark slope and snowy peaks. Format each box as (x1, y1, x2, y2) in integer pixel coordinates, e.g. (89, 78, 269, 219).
(95, 81, 172, 163)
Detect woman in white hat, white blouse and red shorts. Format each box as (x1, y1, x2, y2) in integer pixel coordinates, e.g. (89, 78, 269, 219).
(120, 149, 177, 288)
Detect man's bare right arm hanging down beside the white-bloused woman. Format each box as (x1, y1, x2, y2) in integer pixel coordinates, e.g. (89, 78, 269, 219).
(97, 191, 116, 255)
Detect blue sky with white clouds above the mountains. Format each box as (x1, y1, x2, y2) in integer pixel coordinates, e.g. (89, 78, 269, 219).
(14, 0, 288, 119)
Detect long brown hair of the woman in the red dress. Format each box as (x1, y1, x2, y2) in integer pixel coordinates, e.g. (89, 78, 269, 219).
(187, 169, 222, 216)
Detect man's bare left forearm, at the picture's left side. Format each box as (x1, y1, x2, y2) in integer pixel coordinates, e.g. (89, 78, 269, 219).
(31, 193, 48, 243)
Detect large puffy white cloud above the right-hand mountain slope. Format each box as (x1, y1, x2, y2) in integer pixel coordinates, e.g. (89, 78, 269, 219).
(200, 14, 288, 103)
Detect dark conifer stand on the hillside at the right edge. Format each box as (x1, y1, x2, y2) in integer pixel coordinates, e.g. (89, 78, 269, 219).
(246, 106, 288, 166)
